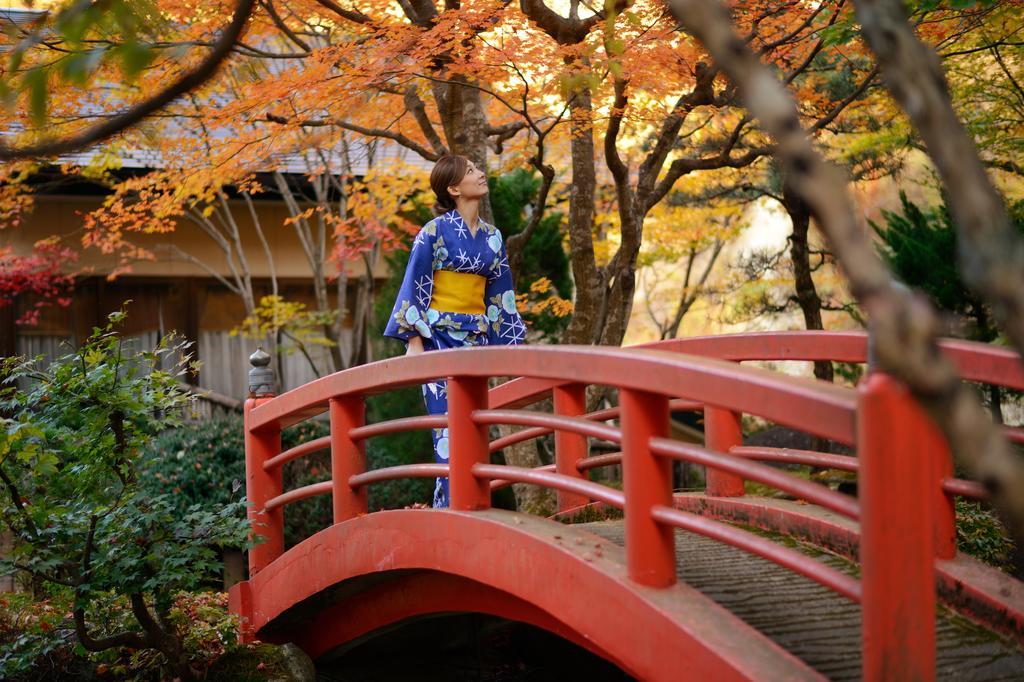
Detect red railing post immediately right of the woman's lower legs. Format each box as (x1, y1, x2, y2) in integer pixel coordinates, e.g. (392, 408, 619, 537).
(447, 377, 490, 511)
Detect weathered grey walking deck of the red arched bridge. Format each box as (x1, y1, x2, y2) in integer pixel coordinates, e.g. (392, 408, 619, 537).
(577, 521, 1024, 681)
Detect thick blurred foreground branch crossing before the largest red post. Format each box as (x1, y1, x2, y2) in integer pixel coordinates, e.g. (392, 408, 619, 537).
(671, 0, 1024, 540)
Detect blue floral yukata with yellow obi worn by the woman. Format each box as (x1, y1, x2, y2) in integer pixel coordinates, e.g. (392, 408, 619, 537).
(384, 206, 526, 508)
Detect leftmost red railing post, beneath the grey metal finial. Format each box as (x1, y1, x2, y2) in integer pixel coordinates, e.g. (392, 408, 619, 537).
(244, 397, 285, 578)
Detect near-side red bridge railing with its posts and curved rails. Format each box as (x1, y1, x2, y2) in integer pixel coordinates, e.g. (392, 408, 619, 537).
(245, 337, 1019, 677)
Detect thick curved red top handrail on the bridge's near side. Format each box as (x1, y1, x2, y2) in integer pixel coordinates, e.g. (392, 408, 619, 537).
(250, 346, 856, 436)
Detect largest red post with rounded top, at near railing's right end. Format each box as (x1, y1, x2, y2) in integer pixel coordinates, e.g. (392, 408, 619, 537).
(857, 373, 936, 680)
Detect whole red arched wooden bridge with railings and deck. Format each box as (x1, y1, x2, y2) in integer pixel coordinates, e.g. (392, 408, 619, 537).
(231, 333, 1024, 680)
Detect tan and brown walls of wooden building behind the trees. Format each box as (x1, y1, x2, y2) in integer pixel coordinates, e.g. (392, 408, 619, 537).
(0, 147, 425, 399)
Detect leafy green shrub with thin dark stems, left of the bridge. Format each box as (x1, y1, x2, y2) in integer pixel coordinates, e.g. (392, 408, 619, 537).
(0, 313, 249, 680)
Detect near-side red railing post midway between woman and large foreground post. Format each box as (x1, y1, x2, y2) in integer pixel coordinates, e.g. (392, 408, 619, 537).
(618, 388, 676, 587)
